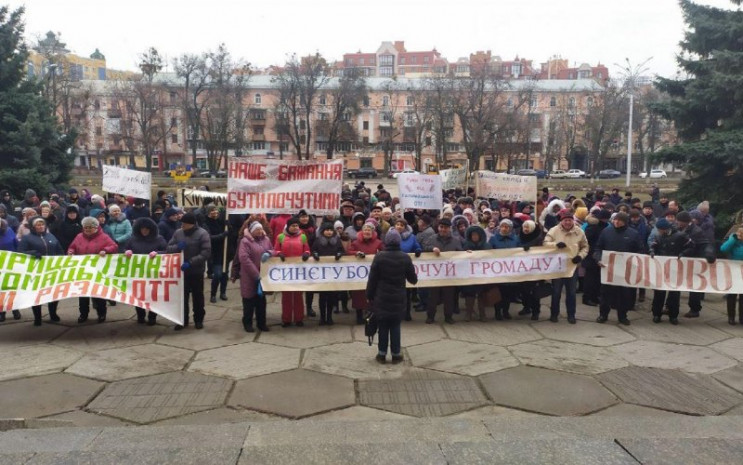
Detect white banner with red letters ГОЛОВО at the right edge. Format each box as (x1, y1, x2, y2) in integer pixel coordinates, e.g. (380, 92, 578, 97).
(601, 252, 743, 294)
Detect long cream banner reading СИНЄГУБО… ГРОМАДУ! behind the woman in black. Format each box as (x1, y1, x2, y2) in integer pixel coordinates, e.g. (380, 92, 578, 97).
(261, 247, 576, 292)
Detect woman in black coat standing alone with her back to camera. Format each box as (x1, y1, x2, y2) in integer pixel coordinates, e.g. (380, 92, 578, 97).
(366, 228, 418, 363)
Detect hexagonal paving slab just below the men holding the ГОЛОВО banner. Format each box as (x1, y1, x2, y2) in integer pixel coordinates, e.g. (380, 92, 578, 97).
(625, 316, 730, 346)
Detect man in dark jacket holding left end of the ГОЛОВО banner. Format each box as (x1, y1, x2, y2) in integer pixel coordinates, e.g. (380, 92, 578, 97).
(593, 212, 644, 325)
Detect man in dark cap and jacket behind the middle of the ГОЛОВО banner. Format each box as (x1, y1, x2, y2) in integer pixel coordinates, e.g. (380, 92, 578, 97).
(650, 218, 694, 325)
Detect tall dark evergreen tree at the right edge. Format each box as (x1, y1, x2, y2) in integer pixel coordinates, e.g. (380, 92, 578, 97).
(655, 0, 743, 231)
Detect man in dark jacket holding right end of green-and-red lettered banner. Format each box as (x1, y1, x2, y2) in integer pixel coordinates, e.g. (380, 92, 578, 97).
(167, 213, 212, 331)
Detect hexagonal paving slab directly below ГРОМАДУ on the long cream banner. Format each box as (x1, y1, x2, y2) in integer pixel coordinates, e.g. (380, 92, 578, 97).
(444, 321, 542, 346)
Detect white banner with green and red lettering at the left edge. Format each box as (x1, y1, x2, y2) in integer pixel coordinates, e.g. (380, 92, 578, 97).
(0, 251, 183, 324)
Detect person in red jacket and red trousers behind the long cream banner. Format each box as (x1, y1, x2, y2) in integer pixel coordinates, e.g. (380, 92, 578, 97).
(273, 217, 310, 328)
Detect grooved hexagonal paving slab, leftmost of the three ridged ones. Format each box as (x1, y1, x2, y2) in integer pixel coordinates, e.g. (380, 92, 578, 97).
(88, 372, 232, 423)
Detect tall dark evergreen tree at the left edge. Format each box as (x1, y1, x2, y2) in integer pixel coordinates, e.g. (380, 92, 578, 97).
(0, 6, 75, 195)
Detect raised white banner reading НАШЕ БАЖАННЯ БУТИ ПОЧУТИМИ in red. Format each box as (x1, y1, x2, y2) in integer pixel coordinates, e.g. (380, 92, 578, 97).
(227, 158, 343, 216)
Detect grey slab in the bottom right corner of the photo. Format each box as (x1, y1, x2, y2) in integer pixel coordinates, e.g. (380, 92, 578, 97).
(618, 438, 743, 465)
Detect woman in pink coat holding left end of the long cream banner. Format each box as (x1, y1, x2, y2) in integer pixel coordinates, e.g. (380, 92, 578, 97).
(232, 220, 273, 333)
